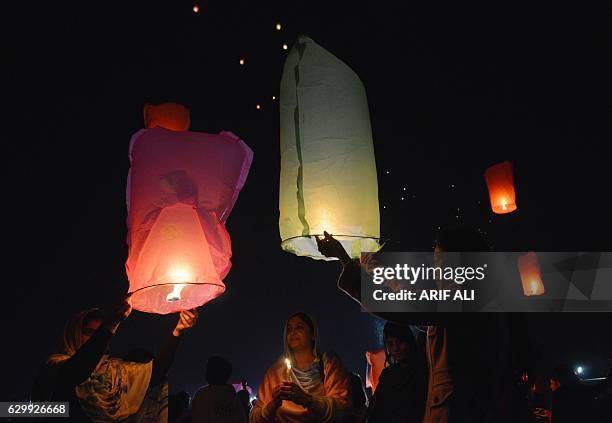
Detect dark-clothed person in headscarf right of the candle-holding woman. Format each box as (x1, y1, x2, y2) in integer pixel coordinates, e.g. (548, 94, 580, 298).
(367, 322, 427, 423)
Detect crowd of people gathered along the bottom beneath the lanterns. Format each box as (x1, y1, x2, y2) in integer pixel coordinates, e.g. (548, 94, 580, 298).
(26, 228, 612, 423)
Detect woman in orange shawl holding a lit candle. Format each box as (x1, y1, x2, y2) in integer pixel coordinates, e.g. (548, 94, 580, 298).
(250, 313, 351, 423)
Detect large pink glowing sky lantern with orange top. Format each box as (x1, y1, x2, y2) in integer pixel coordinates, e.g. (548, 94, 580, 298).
(126, 104, 253, 314)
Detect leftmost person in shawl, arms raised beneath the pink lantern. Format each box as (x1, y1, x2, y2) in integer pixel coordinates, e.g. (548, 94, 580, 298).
(32, 294, 197, 422)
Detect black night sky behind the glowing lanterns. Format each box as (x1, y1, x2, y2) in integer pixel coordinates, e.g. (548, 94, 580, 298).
(0, 0, 612, 399)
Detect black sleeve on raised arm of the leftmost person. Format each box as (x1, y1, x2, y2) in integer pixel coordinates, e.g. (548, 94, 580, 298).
(58, 325, 113, 387)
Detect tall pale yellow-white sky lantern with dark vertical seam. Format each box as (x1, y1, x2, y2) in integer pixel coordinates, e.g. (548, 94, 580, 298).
(279, 37, 380, 260)
